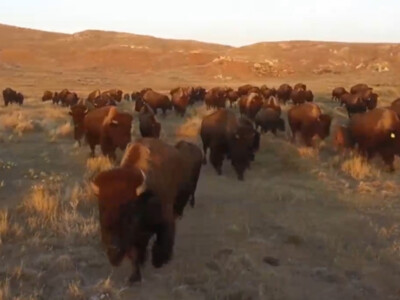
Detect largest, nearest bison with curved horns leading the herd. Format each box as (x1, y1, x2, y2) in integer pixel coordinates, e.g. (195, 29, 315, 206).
(91, 138, 203, 283)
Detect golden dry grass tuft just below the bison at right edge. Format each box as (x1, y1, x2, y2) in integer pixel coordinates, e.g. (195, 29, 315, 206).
(341, 154, 379, 180)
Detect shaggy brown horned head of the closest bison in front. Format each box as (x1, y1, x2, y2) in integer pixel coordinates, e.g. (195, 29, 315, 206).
(91, 168, 146, 266)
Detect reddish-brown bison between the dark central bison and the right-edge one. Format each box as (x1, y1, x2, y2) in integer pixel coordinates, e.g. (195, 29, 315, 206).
(288, 102, 332, 146)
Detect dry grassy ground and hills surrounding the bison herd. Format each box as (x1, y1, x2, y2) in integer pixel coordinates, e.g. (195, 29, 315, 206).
(0, 26, 400, 300)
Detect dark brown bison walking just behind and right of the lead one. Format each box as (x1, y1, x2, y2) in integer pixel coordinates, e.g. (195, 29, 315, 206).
(200, 109, 260, 180)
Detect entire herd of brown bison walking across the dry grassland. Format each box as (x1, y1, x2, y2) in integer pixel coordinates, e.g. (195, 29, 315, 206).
(3, 83, 400, 282)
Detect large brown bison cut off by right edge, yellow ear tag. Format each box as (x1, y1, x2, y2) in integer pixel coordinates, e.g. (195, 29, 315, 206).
(347, 108, 400, 171)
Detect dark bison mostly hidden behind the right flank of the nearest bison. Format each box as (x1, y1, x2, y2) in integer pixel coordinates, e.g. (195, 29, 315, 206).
(174, 141, 203, 217)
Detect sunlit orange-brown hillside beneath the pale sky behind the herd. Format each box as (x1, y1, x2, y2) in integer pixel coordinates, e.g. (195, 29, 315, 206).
(0, 25, 400, 82)
